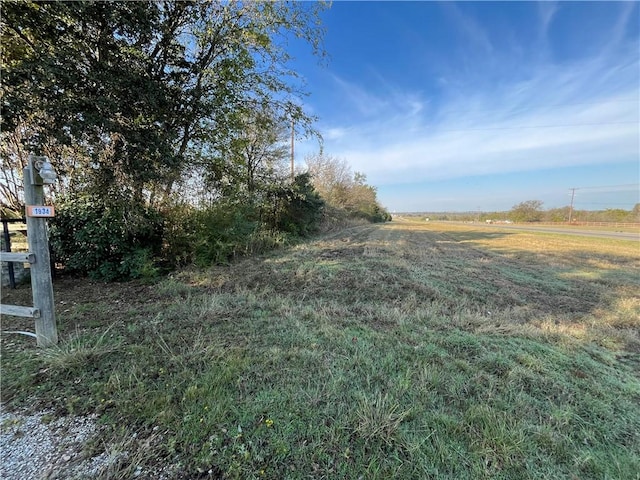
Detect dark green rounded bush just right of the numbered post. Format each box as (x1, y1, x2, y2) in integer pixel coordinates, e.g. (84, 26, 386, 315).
(50, 195, 163, 280)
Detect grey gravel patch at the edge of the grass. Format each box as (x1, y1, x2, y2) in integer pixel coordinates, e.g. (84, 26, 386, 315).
(0, 409, 109, 480)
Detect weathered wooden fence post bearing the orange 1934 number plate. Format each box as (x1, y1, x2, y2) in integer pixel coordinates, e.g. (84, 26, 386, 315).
(23, 157, 58, 347)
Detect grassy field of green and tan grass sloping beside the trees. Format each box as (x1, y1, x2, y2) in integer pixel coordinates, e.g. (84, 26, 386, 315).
(2, 221, 640, 480)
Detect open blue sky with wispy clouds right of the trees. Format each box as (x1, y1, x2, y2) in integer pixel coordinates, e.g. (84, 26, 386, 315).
(292, 1, 640, 212)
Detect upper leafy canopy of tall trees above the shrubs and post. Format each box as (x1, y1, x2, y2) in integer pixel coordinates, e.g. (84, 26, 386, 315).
(1, 0, 325, 204)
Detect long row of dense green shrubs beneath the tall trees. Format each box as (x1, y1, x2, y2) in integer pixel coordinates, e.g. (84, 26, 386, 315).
(51, 174, 324, 280)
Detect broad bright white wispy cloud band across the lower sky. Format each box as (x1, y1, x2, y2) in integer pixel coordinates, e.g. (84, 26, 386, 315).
(308, 31, 640, 185)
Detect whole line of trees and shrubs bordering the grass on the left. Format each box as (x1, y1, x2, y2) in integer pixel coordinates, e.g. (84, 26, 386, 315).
(0, 0, 388, 279)
